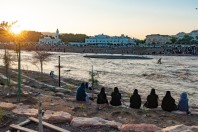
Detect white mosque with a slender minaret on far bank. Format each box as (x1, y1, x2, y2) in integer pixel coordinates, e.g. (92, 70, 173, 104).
(39, 29, 61, 45)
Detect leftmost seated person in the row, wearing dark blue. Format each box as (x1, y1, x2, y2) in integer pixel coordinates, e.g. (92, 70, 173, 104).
(76, 83, 87, 101)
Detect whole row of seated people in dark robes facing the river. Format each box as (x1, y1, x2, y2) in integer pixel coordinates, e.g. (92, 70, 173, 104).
(76, 83, 190, 114)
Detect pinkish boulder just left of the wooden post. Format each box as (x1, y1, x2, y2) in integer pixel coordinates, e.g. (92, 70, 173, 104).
(12, 104, 38, 117)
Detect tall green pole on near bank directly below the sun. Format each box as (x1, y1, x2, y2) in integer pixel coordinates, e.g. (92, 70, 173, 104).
(17, 42, 21, 102)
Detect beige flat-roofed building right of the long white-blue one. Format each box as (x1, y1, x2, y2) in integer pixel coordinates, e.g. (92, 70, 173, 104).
(146, 34, 171, 44)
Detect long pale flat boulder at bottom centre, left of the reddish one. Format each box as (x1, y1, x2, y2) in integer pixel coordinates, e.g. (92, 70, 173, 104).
(71, 117, 122, 128)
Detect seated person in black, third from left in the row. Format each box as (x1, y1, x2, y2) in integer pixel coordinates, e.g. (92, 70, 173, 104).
(110, 87, 122, 106)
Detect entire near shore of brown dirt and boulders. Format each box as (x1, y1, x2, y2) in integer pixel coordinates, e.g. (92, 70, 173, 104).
(0, 67, 198, 132)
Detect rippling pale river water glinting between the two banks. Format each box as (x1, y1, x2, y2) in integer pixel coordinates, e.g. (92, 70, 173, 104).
(0, 50, 198, 103)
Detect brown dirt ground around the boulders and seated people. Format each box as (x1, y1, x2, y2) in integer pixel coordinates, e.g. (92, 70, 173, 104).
(0, 67, 198, 131)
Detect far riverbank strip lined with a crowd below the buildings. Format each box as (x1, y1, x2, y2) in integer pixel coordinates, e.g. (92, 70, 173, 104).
(0, 43, 198, 56)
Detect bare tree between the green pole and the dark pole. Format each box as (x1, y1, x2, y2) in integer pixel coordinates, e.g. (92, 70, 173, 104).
(33, 51, 52, 75)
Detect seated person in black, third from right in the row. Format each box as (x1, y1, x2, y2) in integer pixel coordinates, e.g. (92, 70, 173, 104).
(144, 88, 158, 108)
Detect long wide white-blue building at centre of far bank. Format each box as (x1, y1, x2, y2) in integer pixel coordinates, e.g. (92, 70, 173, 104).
(85, 34, 135, 46)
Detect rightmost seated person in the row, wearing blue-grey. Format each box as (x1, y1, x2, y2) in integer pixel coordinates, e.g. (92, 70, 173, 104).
(178, 92, 190, 114)
